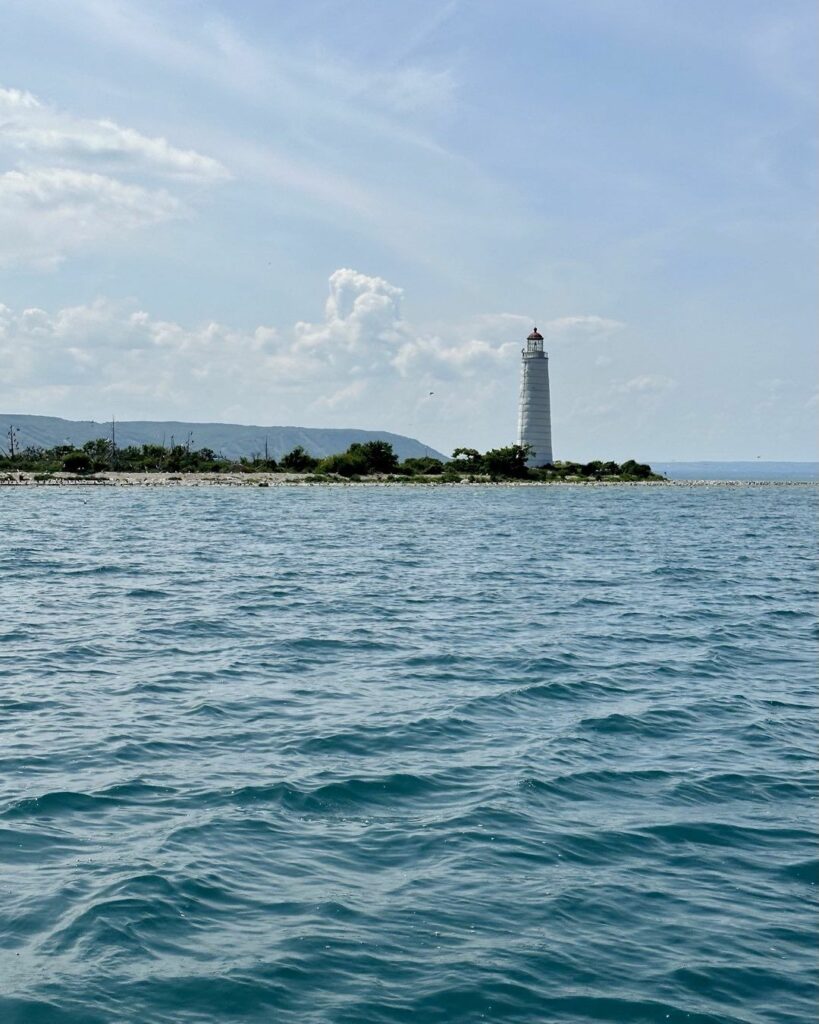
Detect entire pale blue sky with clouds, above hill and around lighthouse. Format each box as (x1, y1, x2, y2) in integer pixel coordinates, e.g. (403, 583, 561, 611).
(0, 0, 819, 461)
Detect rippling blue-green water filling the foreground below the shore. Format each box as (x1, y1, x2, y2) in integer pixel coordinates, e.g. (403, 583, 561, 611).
(0, 486, 817, 1024)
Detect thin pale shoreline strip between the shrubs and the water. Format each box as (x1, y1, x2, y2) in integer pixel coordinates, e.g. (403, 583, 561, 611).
(0, 472, 819, 487)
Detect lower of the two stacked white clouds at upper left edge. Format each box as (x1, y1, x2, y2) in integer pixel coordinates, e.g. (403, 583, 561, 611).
(0, 168, 184, 267)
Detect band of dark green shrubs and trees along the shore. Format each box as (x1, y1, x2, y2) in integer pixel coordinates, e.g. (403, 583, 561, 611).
(0, 438, 662, 482)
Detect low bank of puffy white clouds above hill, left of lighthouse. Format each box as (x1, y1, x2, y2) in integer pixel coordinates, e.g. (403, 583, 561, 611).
(0, 268, 647, 447)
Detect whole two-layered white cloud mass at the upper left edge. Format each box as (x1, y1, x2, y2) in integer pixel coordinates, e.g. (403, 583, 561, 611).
(0, 89, 228, 268)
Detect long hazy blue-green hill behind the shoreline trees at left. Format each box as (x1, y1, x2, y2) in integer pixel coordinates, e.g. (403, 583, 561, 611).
(0, 413, 444, 459)
